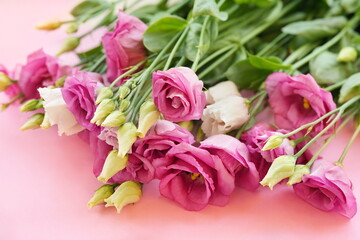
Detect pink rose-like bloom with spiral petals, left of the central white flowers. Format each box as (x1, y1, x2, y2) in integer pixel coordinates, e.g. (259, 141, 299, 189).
(152, 67, 206, 122)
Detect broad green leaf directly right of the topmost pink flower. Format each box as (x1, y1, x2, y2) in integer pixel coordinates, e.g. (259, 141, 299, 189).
(143, 16, 187, 52)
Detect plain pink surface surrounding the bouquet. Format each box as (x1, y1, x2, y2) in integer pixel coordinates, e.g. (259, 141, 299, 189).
(0, 0, 360, 240)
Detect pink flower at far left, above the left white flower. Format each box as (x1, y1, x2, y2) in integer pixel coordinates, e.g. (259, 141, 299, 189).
(18, 49, 72, 99)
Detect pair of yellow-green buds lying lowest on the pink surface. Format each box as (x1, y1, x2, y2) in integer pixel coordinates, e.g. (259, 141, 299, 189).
(88, 181, 142, 213)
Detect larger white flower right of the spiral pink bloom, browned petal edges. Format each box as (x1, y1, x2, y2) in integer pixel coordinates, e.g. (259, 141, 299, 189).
(201, 96, 249, 137)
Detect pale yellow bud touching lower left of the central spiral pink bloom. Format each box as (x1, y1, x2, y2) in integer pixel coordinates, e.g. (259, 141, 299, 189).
(137, 100, 160, 138)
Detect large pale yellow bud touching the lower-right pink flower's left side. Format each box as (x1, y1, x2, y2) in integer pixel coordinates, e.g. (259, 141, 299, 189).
(260, 155, 296, 190)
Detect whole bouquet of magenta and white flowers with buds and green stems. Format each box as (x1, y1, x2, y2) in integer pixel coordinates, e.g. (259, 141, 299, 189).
(0, 0, 360, 218)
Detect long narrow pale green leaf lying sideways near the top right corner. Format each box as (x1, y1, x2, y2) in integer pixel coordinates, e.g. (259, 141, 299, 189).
(282, 16, 347, 40)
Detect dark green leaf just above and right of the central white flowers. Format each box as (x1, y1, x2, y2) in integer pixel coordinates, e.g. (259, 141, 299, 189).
(225, 59, 272, 90)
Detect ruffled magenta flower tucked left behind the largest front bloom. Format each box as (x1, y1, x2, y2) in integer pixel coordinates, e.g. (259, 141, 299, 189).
(113, 120, 194, 183)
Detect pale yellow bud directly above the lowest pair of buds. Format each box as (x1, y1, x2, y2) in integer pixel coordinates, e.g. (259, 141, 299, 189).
(97, 150, 128, 182)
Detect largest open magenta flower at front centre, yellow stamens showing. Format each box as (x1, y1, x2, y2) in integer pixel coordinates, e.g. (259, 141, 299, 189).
(160, 143, 235, 211)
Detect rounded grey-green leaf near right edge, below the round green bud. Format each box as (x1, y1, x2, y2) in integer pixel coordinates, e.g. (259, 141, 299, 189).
(309, 51, 352, 84)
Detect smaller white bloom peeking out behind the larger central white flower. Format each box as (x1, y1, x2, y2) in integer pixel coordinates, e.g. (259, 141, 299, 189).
(205, 81, 241, 104)
